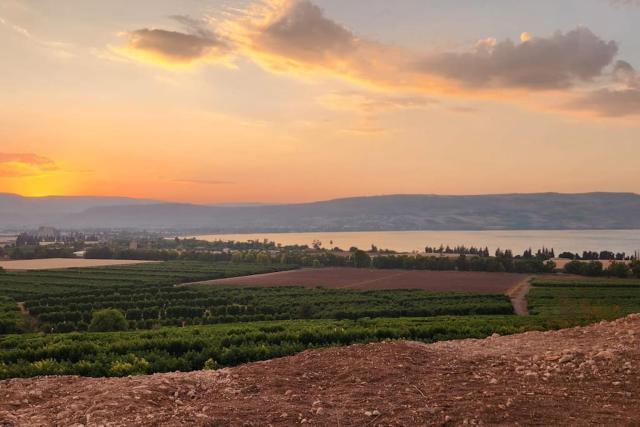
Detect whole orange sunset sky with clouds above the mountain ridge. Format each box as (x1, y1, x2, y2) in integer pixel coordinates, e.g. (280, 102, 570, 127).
(0, 0, 640, 203)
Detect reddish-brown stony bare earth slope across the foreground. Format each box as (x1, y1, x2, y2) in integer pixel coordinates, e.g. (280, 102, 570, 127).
(0, 315, 640, 426)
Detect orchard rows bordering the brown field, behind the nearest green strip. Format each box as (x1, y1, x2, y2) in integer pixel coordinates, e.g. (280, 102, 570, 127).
(0, 262, 513, 333)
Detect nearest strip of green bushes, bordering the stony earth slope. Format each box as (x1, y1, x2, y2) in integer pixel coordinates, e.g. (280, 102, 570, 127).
(0, 316, 580, 378)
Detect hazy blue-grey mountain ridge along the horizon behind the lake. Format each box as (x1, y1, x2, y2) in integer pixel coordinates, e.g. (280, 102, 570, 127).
(0, 193, 640, 233)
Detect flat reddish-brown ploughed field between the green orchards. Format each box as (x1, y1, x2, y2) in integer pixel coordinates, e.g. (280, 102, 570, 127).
(188, 267, 527, 293)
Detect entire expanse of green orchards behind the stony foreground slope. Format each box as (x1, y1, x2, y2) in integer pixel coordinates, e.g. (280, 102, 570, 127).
(0, 268, 640, 378)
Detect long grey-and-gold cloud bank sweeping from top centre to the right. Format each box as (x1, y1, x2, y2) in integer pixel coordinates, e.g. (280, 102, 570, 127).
(236, 0, 618, 94)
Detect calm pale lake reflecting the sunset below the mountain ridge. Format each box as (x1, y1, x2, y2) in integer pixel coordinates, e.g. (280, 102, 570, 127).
(195, 230, 640, 254)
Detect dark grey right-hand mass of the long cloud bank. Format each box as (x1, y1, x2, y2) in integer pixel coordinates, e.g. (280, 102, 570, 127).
(419, 27, 618, 90)
